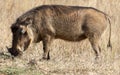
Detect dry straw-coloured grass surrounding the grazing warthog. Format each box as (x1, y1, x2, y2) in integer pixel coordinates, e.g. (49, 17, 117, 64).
(0, 0, 120, 75)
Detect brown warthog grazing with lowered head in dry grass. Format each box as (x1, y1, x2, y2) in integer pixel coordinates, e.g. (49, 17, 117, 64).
(8, 5, 111, 60)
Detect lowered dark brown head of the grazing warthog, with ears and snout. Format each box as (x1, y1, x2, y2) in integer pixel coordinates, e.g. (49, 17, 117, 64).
(8, 18, 33, 56)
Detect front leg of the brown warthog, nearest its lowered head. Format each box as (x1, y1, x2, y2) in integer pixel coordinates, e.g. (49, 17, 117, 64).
(43, 36, 52, 60)
